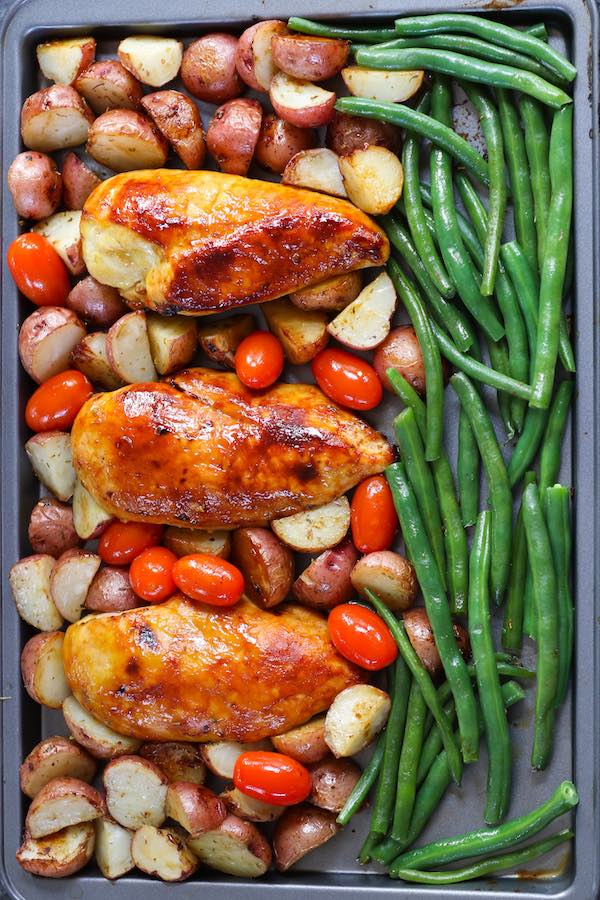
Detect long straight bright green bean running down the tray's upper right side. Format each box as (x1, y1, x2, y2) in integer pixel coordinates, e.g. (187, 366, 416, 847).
(530, 107, 573, 409)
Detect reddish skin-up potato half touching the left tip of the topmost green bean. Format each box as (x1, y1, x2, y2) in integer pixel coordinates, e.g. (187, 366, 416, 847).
(271, 34, 350, 81)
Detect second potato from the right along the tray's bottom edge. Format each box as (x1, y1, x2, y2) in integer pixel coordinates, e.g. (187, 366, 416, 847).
(188, 815, 271, 878)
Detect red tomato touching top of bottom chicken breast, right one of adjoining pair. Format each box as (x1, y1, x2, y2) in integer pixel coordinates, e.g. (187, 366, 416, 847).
(173, 553, 244, 606)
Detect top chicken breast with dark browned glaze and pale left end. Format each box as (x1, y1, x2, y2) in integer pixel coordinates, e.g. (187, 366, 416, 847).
(81, 169, 389, 314)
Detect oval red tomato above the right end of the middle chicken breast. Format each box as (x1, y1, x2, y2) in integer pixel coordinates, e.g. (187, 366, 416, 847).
(312, 350, 383, 409)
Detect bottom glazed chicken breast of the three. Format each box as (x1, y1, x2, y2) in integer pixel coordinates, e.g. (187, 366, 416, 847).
(63, 595, 363, 741)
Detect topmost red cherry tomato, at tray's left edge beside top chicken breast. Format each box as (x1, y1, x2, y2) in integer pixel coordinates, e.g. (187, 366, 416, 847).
(6, 231, 71, 306)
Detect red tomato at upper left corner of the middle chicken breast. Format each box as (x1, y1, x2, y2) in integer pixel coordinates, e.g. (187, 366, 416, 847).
(25, 369, 94, 431)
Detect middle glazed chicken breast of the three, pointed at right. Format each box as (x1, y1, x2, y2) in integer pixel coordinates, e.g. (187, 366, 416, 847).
(71, 369, 393, 528)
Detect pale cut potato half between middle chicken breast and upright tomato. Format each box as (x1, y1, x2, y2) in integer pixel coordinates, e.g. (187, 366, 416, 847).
(271, 496, 350, 553)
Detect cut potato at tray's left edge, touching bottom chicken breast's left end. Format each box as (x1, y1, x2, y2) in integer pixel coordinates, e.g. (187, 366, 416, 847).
(21, 631, 71, 708)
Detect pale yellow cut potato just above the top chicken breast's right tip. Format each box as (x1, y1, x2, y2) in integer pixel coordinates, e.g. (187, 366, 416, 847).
(340, 146, 404, 216)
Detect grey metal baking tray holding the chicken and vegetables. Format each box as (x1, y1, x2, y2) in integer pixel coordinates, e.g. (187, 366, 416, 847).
(0, 0, 600, 900)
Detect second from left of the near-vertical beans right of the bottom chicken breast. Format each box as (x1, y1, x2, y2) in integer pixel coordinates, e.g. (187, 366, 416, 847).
(391, 681, 427, 841)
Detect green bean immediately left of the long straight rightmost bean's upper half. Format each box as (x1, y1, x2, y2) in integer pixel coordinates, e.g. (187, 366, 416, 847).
(519, 94, 550, 272)
